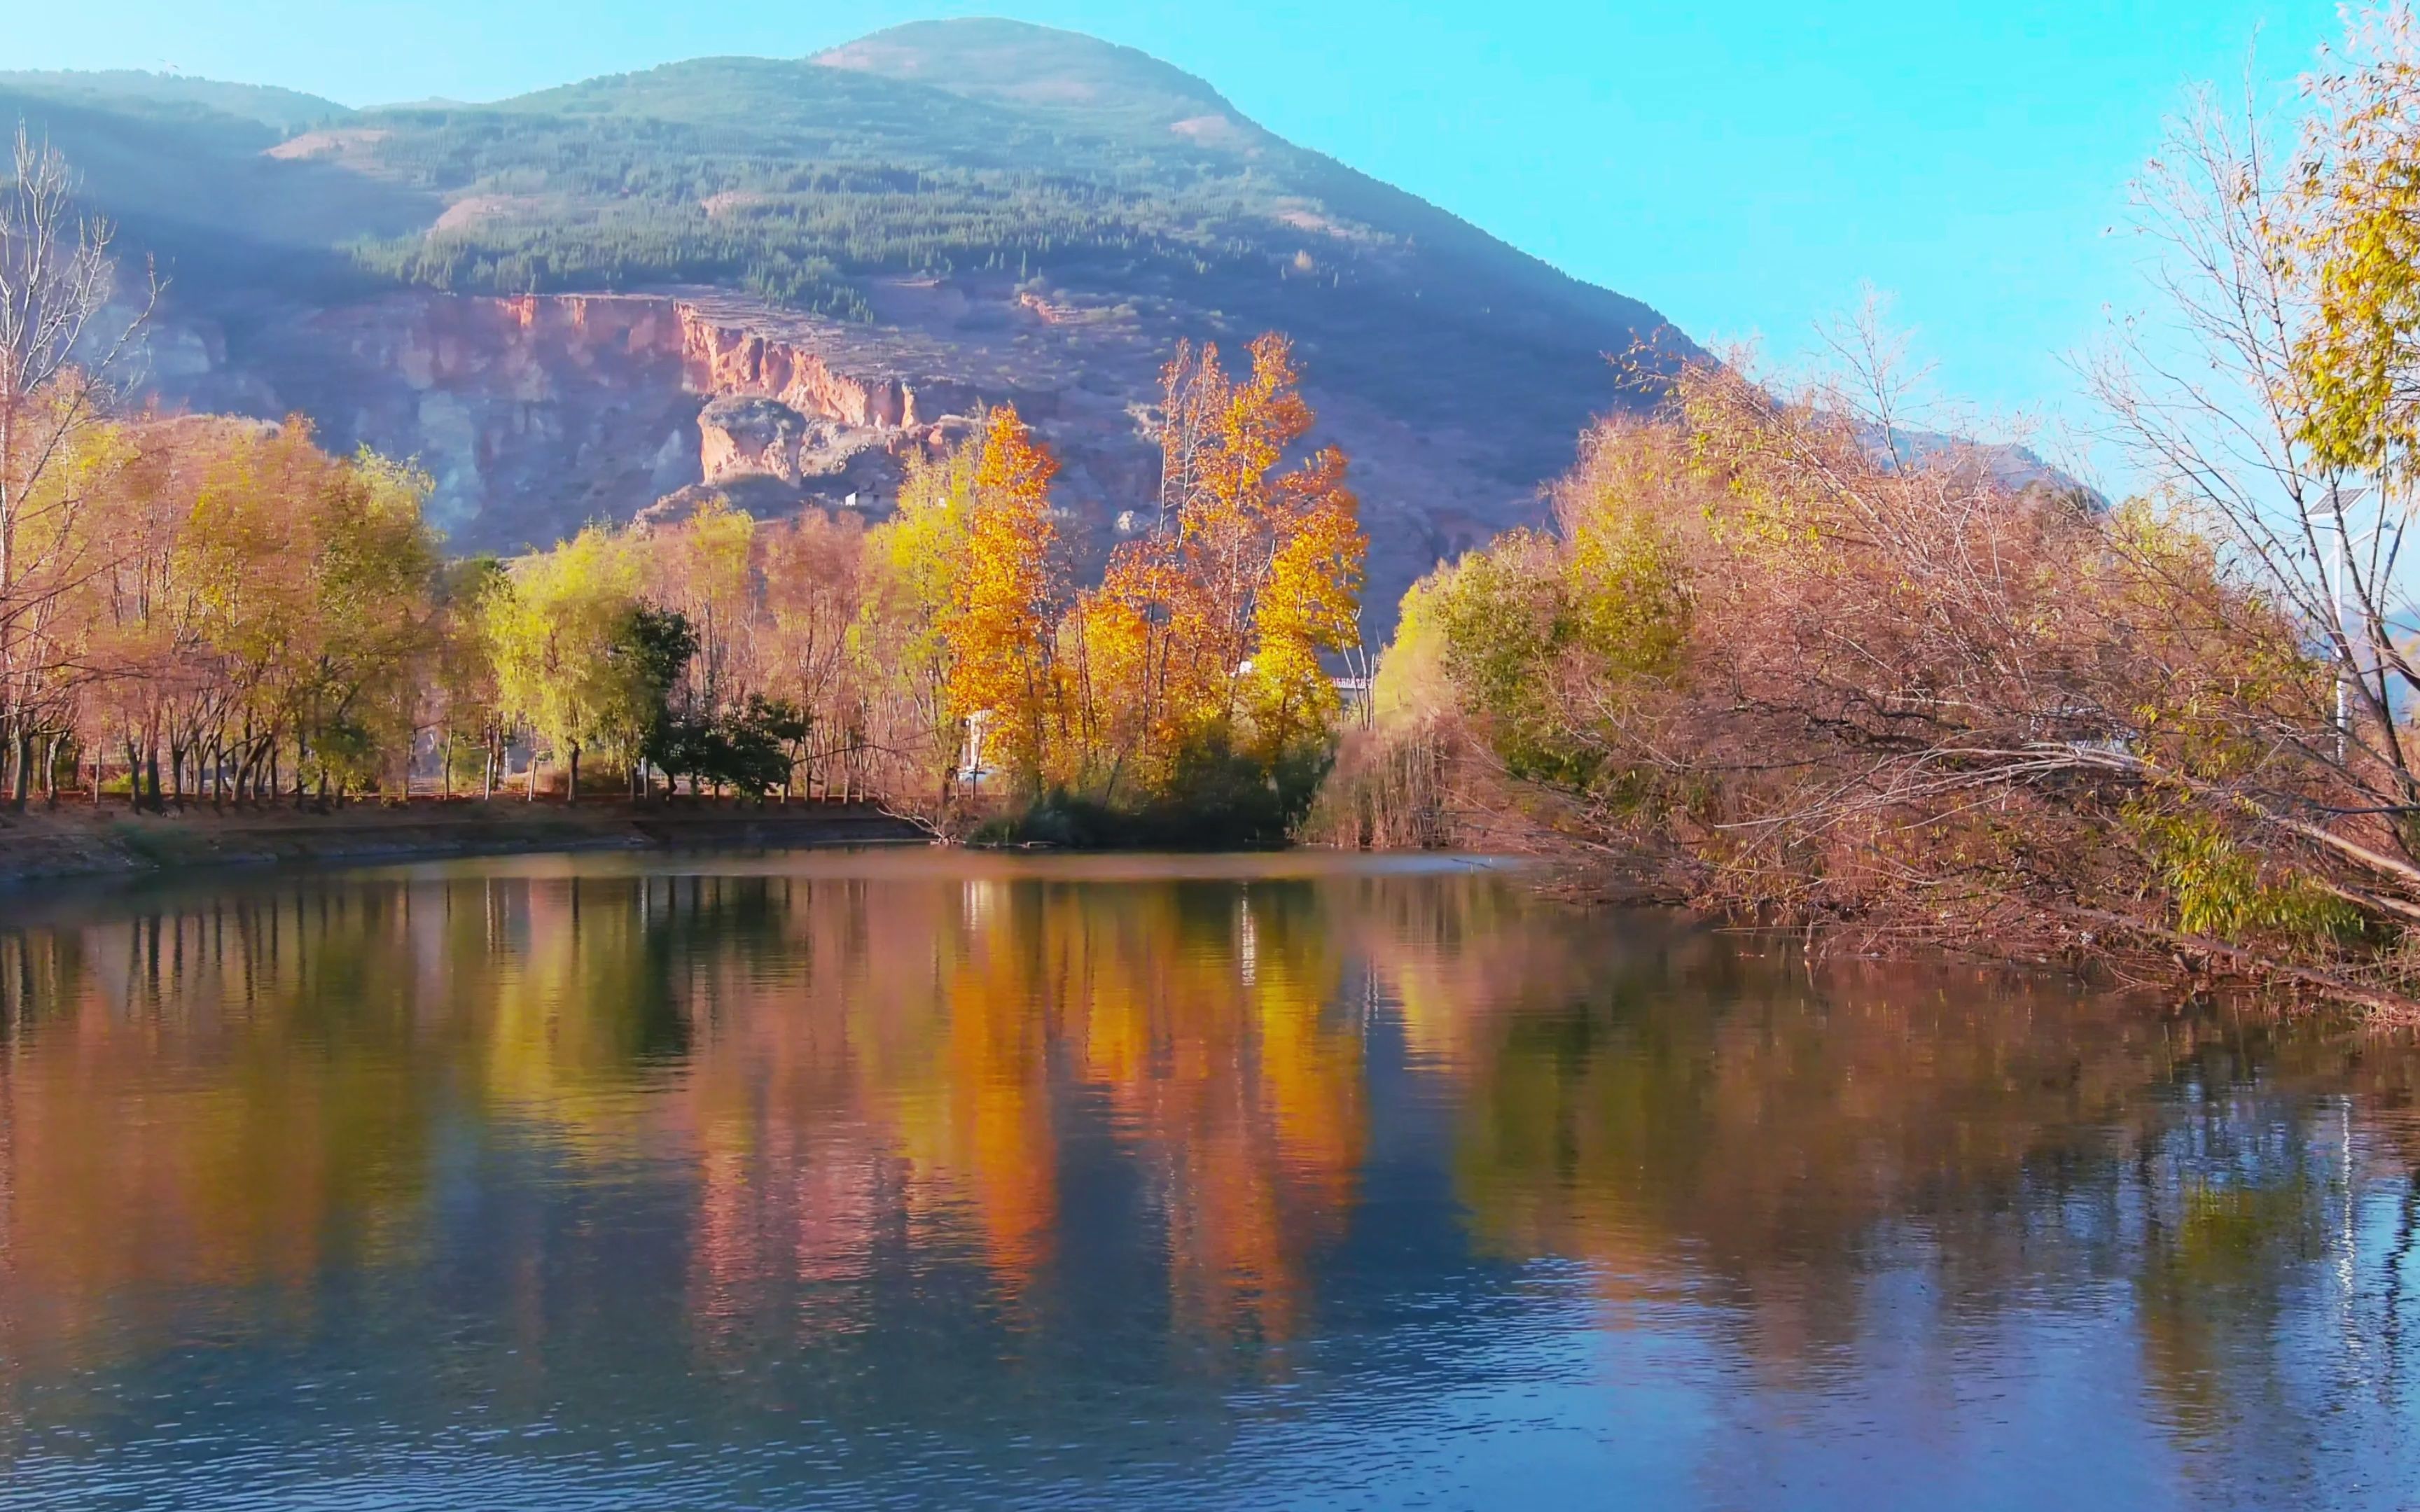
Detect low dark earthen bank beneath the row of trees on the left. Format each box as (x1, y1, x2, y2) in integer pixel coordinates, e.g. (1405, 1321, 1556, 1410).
(0, 798, 924, 888)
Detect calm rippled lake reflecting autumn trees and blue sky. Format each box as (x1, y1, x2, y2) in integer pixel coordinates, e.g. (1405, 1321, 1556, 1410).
(0, 849, 2420, 1512)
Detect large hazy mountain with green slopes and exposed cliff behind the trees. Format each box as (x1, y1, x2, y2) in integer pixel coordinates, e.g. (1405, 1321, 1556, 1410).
(0, 20, 1694, 622)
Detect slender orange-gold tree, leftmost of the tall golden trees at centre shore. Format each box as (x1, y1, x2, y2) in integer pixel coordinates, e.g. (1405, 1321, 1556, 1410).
(946, 407, 1060, 794)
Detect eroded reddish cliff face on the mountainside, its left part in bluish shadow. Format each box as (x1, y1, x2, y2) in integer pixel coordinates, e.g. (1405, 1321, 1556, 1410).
(148, 293, 973, 552)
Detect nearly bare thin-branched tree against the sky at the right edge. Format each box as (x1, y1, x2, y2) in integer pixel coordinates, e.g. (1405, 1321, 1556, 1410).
(2089, 29, 2420, 851)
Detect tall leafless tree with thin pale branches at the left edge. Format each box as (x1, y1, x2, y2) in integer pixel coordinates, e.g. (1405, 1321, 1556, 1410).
(0, 126, 158, 808)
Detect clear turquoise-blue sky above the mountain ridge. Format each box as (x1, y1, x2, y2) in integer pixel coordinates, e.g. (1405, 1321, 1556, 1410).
(0, 0, 2335, 433)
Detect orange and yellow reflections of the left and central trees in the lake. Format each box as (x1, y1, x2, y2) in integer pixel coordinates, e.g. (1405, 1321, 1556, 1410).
(0, 866, 1365, 1340)
